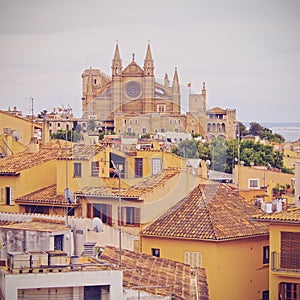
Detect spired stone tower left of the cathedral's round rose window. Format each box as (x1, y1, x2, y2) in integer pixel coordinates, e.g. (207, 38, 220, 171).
(111, 43, 123, 112)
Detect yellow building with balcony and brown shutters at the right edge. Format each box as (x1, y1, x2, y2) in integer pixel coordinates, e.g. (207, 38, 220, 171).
(253, 208, 300, 300)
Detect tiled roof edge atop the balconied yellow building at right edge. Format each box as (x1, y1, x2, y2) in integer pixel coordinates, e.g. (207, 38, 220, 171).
(252, 208, 300, 224)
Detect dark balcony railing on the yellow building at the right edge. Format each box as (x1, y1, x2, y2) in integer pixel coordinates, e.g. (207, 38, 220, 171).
(271, 251, 300, 272)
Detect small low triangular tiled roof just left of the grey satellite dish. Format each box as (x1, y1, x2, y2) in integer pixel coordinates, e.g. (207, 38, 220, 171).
(15, 184, 77, 206)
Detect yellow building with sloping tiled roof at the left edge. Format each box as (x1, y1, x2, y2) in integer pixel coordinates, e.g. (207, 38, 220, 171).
(0, 140, 71, 212)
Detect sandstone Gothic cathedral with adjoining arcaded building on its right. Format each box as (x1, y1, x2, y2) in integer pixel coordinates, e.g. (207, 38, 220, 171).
(82, 44, 236, 140)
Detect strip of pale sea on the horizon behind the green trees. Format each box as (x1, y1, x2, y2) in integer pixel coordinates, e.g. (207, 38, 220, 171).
(243, 122, 300, 142)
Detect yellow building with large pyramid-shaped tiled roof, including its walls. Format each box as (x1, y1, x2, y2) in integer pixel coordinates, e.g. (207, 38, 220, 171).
(141, 184, 269, 300)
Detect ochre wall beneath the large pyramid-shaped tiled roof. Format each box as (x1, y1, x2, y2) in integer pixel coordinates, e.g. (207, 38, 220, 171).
(141, 236, 269, 300)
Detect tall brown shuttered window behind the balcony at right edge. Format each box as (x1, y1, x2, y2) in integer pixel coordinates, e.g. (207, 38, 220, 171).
(280, 232, 300, 270)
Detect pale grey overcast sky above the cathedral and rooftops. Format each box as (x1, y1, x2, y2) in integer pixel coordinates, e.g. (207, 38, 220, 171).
(0, 0, 300, 122)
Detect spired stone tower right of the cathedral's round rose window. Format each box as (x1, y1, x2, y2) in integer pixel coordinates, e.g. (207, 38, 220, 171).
(143, 43, 154, 113)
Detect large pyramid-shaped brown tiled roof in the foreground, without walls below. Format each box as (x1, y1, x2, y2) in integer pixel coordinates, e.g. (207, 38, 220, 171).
(142, 184, 268, 241)
